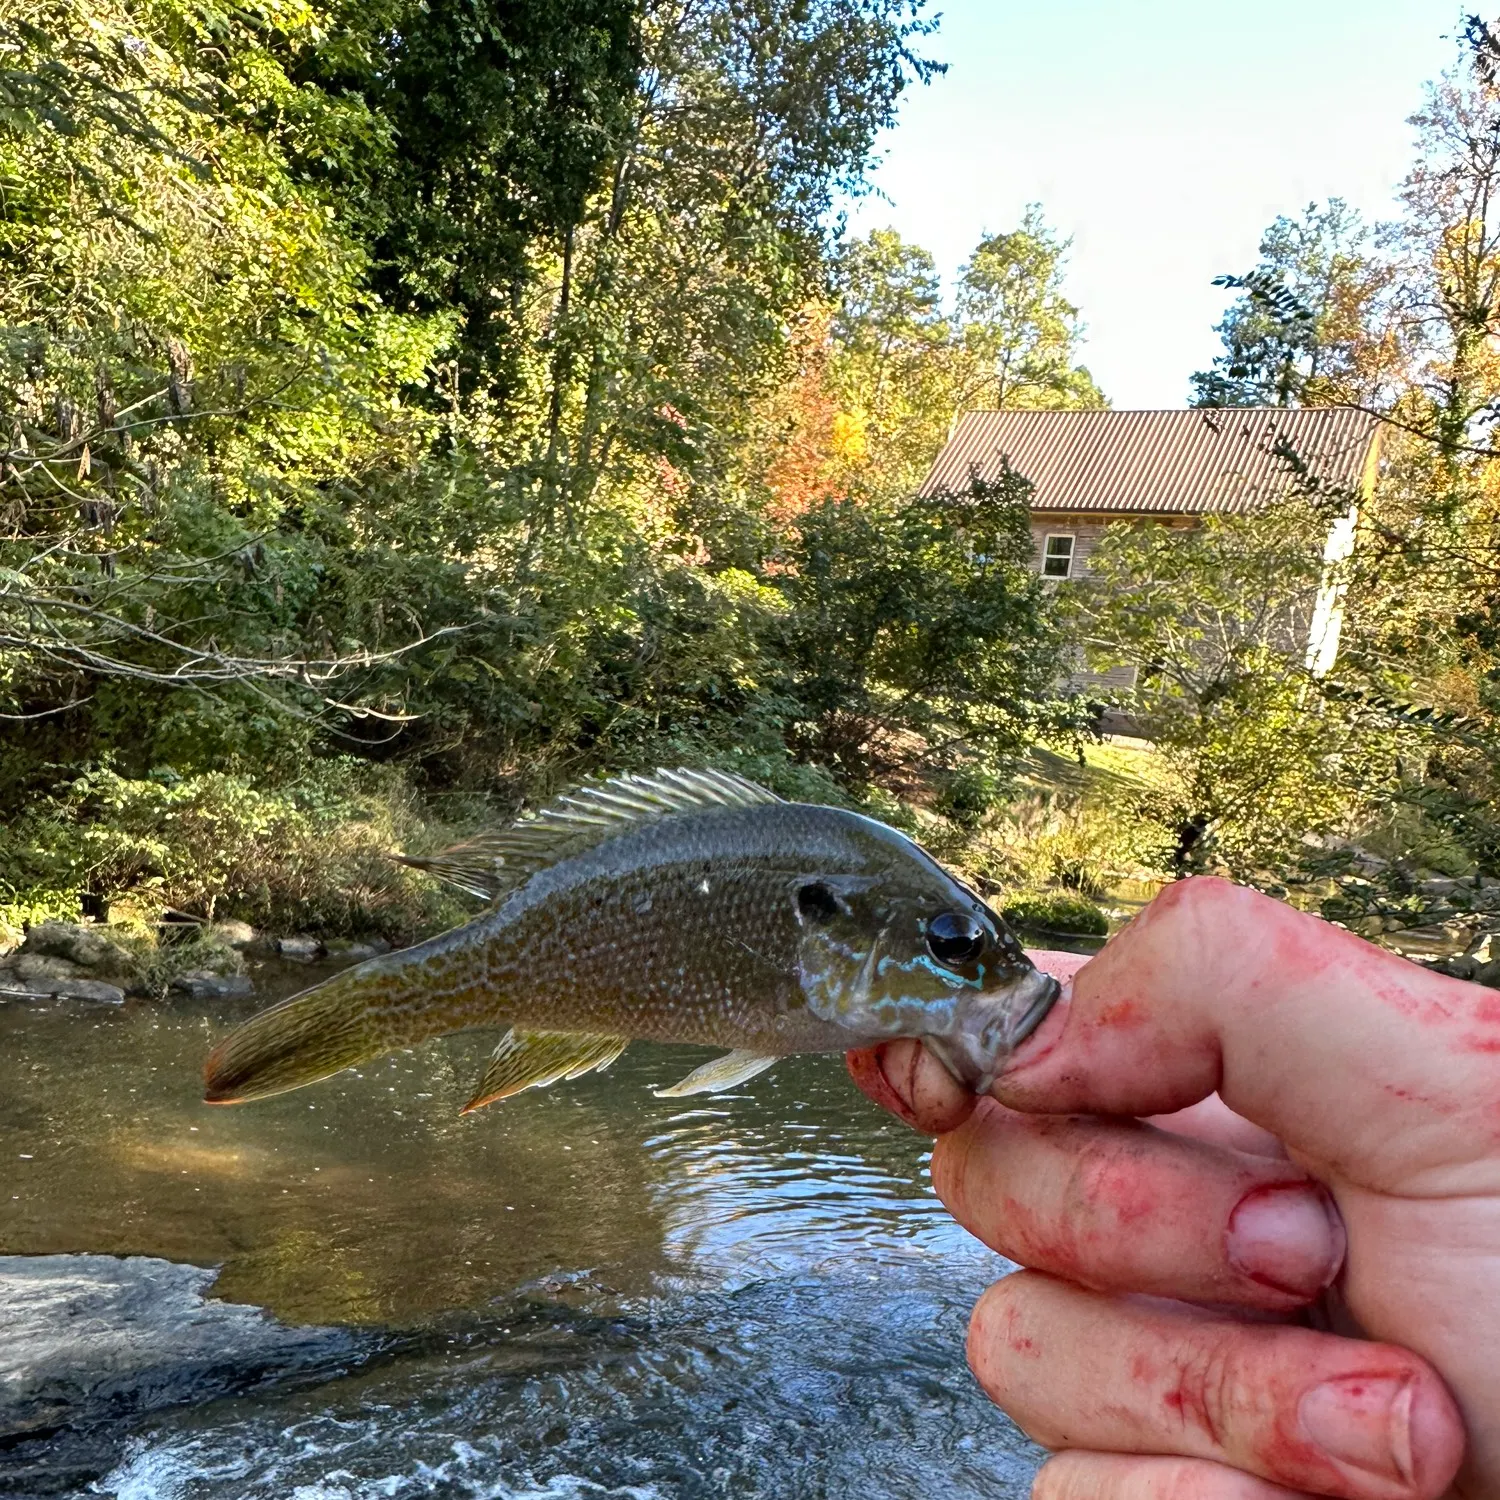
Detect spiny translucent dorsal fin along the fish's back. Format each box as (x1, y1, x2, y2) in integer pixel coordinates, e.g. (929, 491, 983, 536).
(396, 771, 782, 902)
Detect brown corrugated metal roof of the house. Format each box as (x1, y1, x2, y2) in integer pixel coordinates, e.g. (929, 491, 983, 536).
(923, 407, 1380, 513)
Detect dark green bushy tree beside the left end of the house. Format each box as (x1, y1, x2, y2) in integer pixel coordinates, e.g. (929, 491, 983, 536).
(776, 474, 1065, 783)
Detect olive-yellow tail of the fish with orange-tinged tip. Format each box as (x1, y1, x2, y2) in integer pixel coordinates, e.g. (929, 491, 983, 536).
(203, 939, 482, 1104)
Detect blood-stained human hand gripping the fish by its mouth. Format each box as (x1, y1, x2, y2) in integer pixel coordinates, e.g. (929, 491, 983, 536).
(849, 879, 1500, 1500)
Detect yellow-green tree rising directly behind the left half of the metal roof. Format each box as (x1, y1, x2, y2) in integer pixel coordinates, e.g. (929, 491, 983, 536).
(957, 204, 1106, 411)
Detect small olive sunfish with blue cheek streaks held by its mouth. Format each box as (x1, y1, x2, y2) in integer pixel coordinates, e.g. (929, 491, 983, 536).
(204, 770, 1059, 1112)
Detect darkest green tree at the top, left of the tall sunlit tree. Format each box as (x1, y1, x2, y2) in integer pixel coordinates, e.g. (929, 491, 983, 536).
(294, 0, 642, 401)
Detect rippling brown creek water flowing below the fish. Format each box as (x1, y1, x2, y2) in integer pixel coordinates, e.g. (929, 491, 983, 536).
(0, 969, 1040, 1500)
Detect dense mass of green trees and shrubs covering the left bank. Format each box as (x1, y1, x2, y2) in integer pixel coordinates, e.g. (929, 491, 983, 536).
(0, 0, 1092, 938)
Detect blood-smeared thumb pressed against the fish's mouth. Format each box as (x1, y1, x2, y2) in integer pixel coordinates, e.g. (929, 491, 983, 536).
(993, 879, 1500, 1175)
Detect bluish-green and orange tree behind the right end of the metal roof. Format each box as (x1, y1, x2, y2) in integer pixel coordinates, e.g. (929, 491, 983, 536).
(1193, 198, 1403, 407)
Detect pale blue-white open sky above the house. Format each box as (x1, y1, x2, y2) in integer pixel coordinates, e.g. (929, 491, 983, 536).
(849, 0, 1478, 408)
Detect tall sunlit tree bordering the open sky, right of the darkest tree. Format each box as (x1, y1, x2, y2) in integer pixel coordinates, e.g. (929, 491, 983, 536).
(516, 0, 930, 534)
